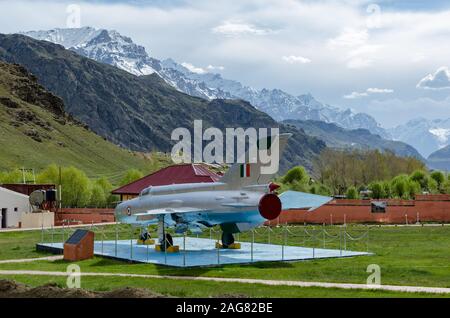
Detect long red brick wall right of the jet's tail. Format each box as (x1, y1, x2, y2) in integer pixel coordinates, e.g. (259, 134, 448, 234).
(272, 195, 450, 224)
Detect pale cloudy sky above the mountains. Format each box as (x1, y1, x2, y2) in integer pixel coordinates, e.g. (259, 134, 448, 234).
(0, 0, 450, 127)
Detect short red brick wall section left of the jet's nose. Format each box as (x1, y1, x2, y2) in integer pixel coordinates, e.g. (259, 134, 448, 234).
(55, 208, 115, 225)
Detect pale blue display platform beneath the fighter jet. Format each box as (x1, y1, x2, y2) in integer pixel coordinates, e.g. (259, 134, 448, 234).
(37, 237, 372, 267)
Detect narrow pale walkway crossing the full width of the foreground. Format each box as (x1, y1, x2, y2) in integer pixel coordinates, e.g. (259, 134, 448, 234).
(0, 270, 450, 294)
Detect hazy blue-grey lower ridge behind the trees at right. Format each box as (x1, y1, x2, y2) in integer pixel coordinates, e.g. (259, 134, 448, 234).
(283, 120, 425, 162)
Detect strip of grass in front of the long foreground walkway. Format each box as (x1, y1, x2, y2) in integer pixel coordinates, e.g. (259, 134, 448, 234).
(0, 275, 449, 298)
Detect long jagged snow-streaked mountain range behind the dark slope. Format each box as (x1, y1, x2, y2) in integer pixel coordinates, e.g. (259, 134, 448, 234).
(23, 27, 389, 137)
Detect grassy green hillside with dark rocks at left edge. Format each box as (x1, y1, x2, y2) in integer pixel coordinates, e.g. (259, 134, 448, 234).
(0, 62, 168, 182)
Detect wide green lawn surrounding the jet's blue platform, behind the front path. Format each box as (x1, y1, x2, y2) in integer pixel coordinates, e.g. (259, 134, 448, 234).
(0, 226, 450, 297)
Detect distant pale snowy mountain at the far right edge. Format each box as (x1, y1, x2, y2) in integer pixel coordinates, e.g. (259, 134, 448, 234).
(388, 118, 450, 157)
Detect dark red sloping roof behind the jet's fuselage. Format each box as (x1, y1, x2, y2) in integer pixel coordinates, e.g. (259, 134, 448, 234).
(112, 164, 220, 195)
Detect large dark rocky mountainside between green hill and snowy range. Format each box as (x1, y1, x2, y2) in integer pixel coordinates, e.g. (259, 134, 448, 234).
(0, 35, 325, 173)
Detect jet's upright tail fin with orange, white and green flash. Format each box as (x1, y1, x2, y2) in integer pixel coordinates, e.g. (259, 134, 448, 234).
(220, 134, 292, 189)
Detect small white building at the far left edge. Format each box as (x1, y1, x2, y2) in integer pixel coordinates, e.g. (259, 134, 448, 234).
(0, 187, 31, 228)
